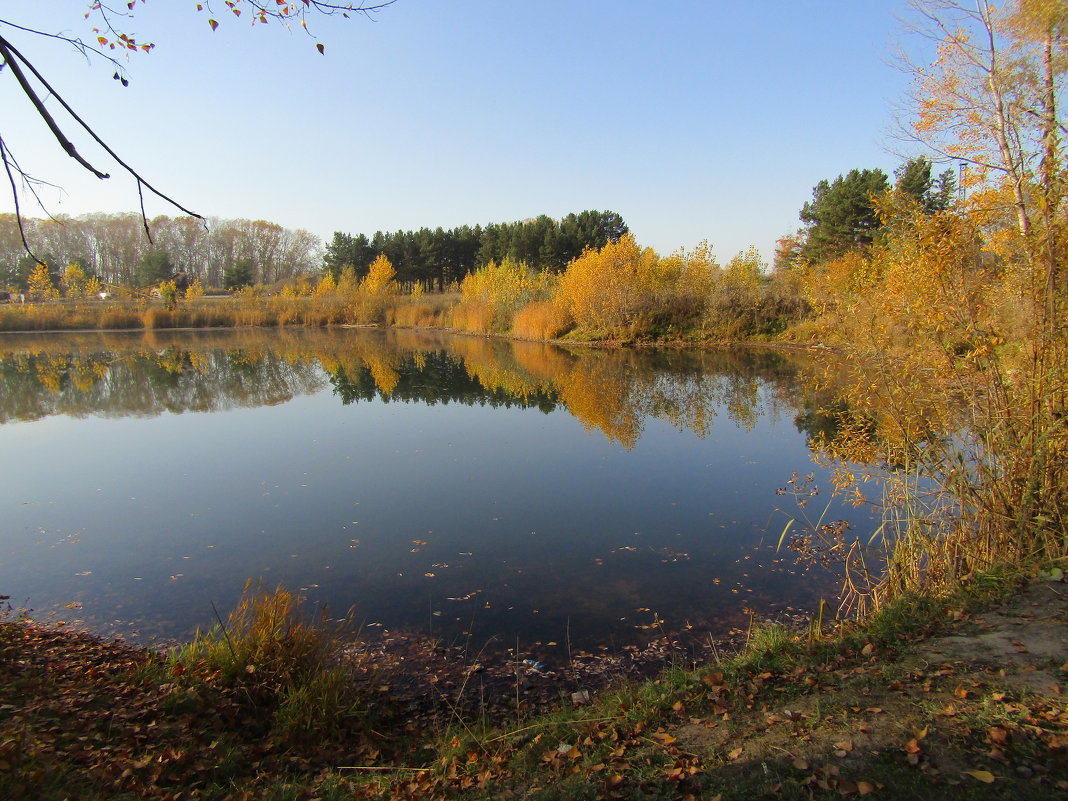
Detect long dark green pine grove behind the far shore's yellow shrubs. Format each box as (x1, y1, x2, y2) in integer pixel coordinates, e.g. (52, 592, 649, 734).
(324, 210, 628, 287)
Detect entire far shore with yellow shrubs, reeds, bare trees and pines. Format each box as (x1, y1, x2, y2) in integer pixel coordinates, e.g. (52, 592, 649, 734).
(0, 156, 957, 344)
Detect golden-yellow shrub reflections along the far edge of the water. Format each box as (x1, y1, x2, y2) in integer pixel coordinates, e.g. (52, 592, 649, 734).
(4, 330, 803, 449)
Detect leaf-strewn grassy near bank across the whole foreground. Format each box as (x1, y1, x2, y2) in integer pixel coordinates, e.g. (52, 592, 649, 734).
(0, 572, 1068, 801)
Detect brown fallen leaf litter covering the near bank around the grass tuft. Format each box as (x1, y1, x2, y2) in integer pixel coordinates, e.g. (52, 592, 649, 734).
(0, 582, 1068, 801)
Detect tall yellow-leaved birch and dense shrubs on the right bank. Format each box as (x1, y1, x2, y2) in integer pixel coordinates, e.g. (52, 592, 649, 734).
(810, 0, 1068, 606)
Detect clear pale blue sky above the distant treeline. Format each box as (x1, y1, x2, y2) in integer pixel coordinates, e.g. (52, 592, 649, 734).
(0, 0, 922, 261)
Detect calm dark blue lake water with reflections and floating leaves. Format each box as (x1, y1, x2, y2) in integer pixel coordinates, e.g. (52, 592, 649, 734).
(0, 330, 857, 648)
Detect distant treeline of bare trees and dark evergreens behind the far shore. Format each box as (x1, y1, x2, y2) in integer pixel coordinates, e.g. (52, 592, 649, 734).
(0, 211, 628, 290)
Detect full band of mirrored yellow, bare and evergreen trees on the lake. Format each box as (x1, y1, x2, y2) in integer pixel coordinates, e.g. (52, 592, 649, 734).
(0, 330, 812, 449)
